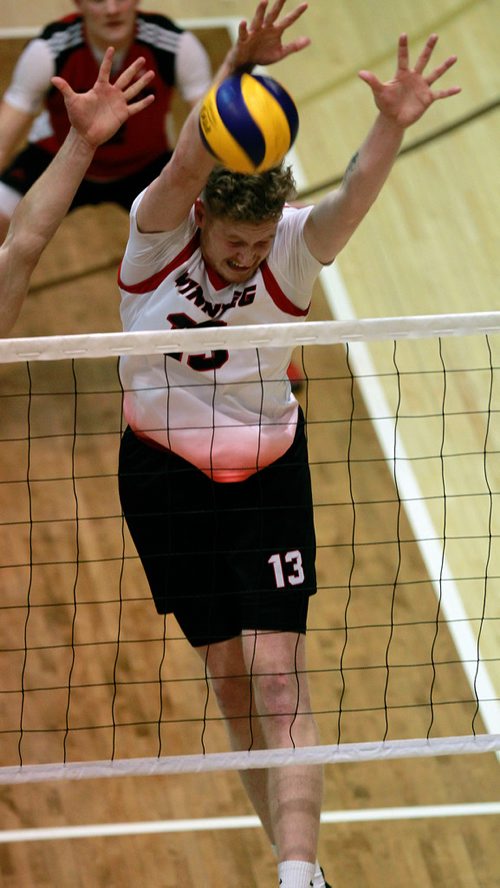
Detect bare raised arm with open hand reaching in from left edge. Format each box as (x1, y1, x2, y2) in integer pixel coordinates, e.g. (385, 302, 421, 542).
(0, 48, 154, 336)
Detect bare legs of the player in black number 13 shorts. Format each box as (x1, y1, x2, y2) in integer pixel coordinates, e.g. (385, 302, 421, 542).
(196, 631, 325, 886)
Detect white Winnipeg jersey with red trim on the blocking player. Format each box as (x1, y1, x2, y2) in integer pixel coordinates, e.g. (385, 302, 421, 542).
(119, 195, 321, 481)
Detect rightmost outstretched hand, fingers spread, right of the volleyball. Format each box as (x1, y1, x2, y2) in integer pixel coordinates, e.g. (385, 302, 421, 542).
(359, 34, 461, 128)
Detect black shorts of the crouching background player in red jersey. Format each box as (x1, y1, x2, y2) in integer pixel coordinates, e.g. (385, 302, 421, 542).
(0, 145, 171, 212)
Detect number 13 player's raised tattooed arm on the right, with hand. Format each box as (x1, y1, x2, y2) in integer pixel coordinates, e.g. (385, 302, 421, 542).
(304, 34, 460, 263)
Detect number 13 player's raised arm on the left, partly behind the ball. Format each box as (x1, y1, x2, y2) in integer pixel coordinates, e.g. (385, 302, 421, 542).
(137, 0, 309, 232)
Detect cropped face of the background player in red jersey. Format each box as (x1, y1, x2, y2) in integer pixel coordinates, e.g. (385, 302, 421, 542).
(75, 0, 139, 50)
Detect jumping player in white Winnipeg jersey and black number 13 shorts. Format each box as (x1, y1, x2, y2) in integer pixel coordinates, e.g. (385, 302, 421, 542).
(119, 0, 459, 888)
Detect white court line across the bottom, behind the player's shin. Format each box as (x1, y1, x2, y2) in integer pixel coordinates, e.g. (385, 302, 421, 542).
(0, 802, 500, 844)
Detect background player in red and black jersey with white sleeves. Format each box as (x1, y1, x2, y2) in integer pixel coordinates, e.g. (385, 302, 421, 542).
(0, 0, 212, 242)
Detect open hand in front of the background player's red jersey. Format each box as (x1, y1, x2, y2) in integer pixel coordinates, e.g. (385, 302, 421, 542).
(52, 47, 154, 148)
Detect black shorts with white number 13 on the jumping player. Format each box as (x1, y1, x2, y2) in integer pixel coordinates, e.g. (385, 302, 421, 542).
(119, 417, 316, 646)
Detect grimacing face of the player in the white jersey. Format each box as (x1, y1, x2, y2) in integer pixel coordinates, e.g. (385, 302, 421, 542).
(196, 205, 278, 284)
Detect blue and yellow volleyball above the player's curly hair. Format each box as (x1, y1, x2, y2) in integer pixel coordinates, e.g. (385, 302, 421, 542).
(199, 74, 299, 173)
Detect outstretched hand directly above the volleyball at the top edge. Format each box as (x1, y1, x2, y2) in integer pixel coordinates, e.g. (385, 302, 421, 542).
(232, 0, 311, 68)
